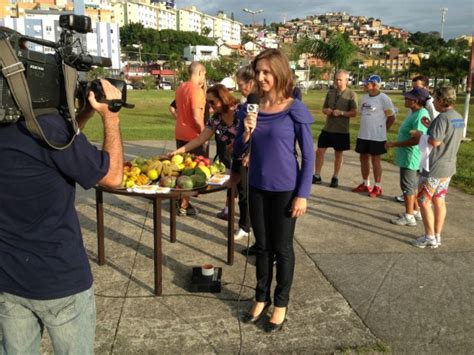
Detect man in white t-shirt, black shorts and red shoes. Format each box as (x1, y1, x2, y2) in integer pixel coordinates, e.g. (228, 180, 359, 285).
(352, 74, 395, 197)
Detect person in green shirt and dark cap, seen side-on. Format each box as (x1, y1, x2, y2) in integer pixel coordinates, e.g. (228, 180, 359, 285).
(385, 88, 430, 226)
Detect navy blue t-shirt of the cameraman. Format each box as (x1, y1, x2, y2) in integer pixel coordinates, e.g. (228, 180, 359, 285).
(0, 115, 109, 300)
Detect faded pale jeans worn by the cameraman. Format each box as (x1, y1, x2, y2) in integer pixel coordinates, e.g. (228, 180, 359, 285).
(0, 287, 96, 355)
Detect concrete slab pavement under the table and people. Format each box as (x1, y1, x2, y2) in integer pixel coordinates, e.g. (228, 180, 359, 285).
(11, 141, 474, 354)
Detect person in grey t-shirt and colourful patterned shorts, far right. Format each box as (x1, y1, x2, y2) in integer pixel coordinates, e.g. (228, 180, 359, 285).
(411, 87, 465, 248)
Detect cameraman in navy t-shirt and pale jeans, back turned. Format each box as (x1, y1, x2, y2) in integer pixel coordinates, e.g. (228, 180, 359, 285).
(0, 80, 123, 354)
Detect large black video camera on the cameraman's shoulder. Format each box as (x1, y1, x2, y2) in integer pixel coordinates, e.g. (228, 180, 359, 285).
(0, 14, 134, 123)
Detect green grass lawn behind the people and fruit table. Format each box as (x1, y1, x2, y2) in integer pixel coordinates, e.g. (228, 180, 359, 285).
(85, 90, 474, 194)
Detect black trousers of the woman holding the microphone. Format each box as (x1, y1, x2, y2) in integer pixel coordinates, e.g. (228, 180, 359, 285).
(249, 186, 296, 307)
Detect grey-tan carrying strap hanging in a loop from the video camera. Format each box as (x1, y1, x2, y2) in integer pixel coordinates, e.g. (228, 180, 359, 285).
(0, 36, 79, 150)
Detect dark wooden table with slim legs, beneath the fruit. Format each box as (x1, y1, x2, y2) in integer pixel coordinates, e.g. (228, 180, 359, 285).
(94, 183, 235, 295)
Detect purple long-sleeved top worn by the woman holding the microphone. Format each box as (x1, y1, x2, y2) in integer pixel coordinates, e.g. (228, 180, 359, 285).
(234, 100, 314, 198)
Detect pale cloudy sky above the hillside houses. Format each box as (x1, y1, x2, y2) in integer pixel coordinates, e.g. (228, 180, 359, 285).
(176, 0, 474, 39)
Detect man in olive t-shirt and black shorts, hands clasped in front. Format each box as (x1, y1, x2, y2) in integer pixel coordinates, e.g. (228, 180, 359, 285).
(313, 70, 357, 191)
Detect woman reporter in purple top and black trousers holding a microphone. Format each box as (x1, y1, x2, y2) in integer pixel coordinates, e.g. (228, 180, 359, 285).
(234, 49, 314, 332)
